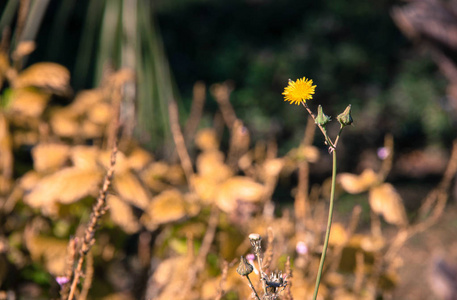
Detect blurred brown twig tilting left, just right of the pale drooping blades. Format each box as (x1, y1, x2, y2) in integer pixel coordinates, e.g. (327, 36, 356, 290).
(168, 100, 194, 182)
